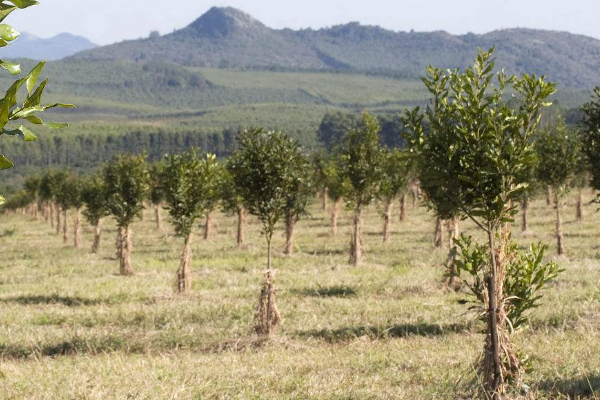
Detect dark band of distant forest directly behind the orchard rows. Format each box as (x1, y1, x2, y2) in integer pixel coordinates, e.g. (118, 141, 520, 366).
(0, 107, 581, 193)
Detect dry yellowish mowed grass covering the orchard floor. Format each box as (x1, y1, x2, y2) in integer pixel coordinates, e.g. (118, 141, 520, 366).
(0, 193, 600, 400)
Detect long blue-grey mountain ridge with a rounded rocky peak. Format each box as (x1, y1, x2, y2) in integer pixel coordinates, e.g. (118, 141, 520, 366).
(69, 7, 600, 88)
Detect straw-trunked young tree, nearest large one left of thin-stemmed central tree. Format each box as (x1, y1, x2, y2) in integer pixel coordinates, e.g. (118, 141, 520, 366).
(160, 149, 222, 294)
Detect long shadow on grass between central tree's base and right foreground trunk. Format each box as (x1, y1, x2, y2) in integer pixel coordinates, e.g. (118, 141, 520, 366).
(297, 322, 468, 343)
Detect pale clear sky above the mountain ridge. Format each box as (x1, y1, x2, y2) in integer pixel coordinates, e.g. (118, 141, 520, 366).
(5, 0, 600, 45)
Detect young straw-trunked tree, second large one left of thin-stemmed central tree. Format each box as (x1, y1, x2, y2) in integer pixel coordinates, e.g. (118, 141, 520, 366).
(102, 155, 149, 275)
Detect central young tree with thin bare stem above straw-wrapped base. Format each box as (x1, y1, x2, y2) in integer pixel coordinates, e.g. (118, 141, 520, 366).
(228, 129, 302, 335)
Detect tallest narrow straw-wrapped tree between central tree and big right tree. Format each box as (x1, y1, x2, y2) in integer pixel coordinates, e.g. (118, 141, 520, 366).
(340, 113, 384, 266)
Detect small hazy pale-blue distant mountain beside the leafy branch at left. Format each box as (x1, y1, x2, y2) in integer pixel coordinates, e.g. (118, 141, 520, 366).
(2, 33, 97, 60)
